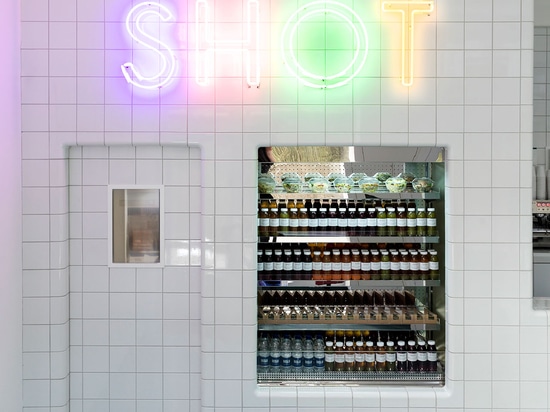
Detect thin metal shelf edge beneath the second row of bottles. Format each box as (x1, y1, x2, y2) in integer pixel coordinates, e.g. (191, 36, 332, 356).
(258, 280, 441, 290)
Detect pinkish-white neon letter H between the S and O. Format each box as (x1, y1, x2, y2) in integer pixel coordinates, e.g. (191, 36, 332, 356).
(195, 0, 260, 87)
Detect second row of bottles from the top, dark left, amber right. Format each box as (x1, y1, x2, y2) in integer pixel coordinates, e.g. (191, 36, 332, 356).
(257, 243, 439, 281)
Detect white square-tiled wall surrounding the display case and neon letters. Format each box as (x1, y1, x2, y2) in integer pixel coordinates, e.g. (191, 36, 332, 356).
(21, 0, 540, 412)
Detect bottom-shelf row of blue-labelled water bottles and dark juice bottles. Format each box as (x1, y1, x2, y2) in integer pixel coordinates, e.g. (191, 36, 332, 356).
(258, 331, 438, 373)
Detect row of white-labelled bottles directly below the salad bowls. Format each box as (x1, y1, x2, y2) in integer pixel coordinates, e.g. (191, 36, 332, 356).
(258, 199, 437, 237)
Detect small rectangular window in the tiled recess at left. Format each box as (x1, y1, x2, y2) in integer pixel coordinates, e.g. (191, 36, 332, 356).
(112, 189, 160, 263)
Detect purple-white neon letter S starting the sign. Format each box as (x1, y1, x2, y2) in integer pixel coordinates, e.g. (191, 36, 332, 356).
(120, 2, 176, 89)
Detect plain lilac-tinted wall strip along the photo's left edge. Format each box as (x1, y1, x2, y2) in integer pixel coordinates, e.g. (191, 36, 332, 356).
(0, 0, 22, 411)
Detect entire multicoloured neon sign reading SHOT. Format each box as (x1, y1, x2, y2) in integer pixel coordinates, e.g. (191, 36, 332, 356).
(121, 0, 434, 90)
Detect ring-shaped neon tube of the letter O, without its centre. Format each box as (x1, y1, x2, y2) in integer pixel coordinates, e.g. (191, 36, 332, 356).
(281, 1, 368, 89)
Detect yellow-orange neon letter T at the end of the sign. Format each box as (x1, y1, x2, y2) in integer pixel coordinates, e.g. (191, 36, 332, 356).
(382, 0, 434, 87)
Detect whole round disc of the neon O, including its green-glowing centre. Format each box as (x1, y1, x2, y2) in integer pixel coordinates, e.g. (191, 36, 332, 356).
(281, 1, 368, 89)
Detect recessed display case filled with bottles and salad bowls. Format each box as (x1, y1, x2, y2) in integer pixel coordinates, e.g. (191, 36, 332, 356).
(257, 147, 445, 385)
